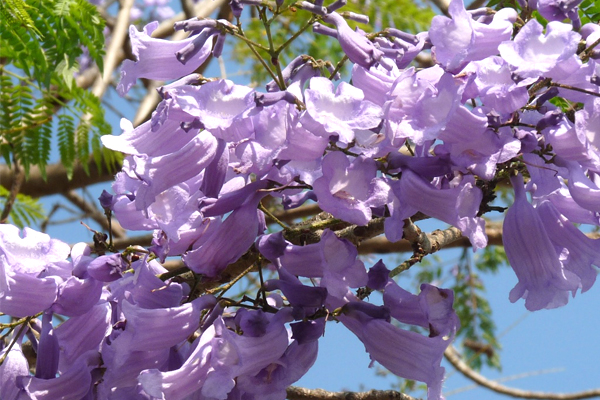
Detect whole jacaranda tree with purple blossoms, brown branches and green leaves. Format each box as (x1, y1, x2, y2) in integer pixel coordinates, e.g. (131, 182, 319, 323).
(0, 0, 600, 400)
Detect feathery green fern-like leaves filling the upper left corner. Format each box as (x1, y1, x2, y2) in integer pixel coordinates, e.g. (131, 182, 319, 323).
(0, 0, 110, 180)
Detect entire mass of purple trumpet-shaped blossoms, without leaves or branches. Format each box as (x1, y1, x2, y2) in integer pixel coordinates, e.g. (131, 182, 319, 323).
(0, 0, 600, 400)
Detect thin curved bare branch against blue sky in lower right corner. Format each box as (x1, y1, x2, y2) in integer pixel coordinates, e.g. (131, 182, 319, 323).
(444, 345, 600, 400)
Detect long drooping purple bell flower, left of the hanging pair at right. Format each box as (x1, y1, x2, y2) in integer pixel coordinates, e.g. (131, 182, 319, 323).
(502, 175, 580, 311)
